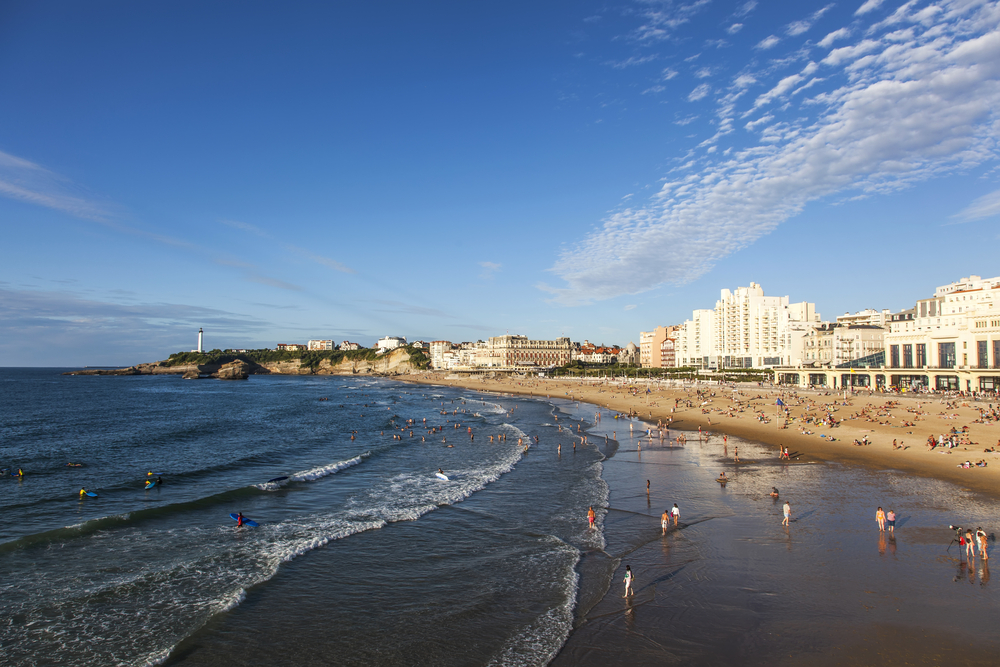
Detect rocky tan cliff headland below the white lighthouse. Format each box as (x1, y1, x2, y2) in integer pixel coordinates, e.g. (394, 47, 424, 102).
(67, 349, 418, 380)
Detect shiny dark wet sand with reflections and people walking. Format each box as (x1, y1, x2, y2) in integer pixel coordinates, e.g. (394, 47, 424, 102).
(552, 408, 1000, 667)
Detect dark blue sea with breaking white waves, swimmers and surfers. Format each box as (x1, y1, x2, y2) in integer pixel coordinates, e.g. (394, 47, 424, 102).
(0, 369, 608, 665)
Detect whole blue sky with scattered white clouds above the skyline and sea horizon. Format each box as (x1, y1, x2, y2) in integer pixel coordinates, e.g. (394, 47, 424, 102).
(0, 0, 1000, 366)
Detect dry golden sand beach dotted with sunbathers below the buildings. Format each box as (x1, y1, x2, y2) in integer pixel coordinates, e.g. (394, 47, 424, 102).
(400, 373, 1000, 496)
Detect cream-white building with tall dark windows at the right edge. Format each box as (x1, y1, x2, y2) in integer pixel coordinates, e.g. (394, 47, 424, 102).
(885, 276, 1000, 391)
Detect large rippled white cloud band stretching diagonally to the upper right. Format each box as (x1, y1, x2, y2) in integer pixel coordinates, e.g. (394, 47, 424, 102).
(539, 0, 1000, 304)
